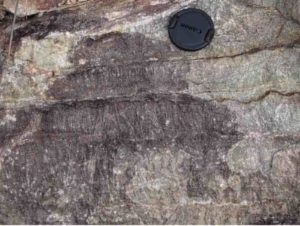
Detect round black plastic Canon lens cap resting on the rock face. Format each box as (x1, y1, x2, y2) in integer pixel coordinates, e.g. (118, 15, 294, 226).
(168, 8, 215, 51)
